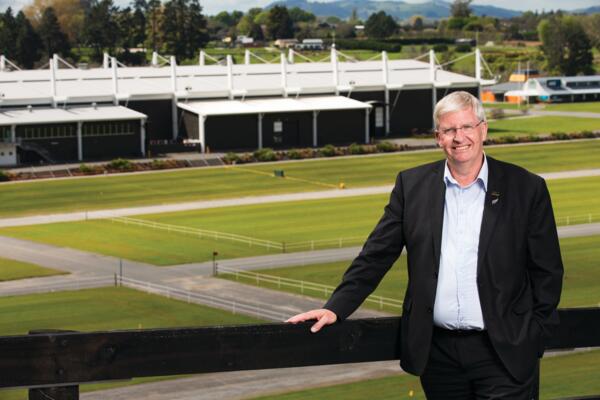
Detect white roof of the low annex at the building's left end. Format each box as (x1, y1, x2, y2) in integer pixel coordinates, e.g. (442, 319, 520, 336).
(0, 106, 146, 125)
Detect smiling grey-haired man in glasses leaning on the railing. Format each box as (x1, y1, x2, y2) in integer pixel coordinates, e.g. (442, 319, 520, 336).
(288, 92, 563, 399)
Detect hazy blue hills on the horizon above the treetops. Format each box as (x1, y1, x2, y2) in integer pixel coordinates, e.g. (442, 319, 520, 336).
(267, 0, 521, 19)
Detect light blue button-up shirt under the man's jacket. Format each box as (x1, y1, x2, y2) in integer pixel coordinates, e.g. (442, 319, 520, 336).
(433, 156, 488, 329)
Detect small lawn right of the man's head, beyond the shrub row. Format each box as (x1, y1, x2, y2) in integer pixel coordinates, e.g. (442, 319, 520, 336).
(488, 116, 600, 137)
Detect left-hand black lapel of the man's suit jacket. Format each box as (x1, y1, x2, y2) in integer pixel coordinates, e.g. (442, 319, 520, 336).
(427, 161, 446, 272)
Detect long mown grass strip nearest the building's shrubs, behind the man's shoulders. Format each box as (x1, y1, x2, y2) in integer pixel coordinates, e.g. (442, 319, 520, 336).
(0, 140, 600, 218)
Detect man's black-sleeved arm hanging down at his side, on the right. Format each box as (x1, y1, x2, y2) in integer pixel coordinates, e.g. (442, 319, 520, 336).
(527, 178, 563, 331)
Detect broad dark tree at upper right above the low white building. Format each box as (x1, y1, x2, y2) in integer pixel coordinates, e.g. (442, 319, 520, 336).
(538, 15, 594, 76)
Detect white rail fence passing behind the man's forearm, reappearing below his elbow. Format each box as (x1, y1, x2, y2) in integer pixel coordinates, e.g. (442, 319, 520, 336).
(217, 266, 402, 310)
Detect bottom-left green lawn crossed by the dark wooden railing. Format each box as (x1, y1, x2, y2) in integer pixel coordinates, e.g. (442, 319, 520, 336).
(0, 287, 262, 400)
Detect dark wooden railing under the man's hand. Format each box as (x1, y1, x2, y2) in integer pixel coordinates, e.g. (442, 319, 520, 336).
(0, 308, 600, 400)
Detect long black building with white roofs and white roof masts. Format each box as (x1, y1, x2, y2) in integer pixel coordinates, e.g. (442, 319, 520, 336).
(0, 48, 486, 165)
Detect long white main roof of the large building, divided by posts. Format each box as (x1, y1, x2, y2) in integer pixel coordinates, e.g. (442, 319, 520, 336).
(0, 60, 478, 107)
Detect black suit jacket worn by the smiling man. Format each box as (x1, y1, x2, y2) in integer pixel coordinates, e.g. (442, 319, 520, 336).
(325, 157, 563, 380)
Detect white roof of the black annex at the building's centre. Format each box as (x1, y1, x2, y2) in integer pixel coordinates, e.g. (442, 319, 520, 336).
(178, 96, 371, 116)
